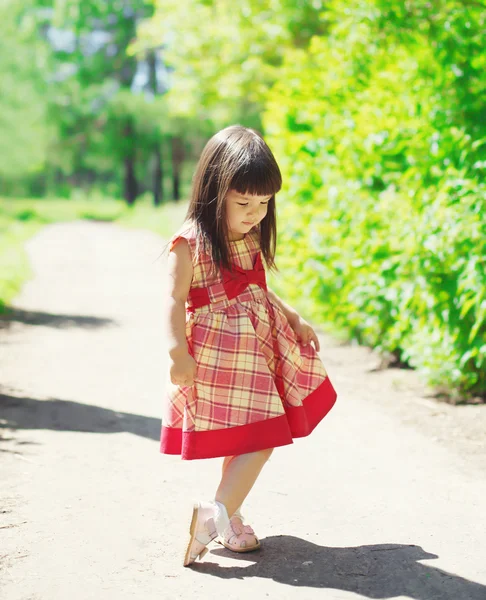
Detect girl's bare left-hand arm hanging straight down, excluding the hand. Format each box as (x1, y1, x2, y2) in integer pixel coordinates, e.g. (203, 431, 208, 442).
(167, 238, 193, 358)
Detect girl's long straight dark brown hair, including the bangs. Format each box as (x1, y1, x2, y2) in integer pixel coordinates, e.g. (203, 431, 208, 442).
(159, 125, 282, 278)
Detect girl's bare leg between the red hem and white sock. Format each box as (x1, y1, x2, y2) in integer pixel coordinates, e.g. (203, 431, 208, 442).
(216, 448, 273, 517)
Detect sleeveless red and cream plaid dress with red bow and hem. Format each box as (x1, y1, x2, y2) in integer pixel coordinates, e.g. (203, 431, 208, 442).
(160, 222, 336, 460)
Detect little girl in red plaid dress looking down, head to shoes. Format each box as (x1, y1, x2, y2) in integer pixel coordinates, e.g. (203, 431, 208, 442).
(160, 125, 336, 566)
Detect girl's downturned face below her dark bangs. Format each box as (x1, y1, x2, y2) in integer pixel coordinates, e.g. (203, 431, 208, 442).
(226, 190, 272, 241)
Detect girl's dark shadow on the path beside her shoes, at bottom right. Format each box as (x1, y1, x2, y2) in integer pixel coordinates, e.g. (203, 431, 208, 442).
(192, 535, 486, 600)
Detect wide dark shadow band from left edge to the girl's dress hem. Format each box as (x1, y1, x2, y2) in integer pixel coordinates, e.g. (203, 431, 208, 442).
(0, 393, 161, 441)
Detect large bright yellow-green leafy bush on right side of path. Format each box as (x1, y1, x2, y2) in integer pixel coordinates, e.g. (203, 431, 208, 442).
(264, 2, 486, 404)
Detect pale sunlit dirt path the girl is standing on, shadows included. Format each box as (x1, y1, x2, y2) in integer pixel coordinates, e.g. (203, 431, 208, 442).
(0, 221, 486, 600)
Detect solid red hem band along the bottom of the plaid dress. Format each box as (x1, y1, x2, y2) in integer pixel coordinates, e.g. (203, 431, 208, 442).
(160, 377, 337, 460)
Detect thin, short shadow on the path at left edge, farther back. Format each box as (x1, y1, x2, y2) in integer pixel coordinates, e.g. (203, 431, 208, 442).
(0, 306, 117, 329)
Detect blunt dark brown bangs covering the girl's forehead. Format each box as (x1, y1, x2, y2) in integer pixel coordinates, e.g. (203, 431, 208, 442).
(230, 153, 282, 196)
